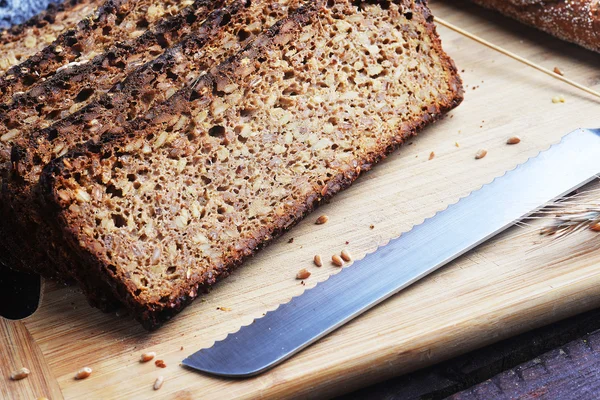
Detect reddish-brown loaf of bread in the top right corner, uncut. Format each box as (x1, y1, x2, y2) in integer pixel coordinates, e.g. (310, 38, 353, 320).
(472, 0, 600, 52)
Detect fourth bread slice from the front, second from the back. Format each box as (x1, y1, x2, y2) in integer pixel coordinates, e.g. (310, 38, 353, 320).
(0, 0, 193, 103)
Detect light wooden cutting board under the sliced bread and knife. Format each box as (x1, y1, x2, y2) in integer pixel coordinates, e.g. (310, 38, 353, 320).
(0, 2, 600, 399)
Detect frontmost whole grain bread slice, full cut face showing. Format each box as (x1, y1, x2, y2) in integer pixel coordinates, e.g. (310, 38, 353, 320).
(40, 0, 462, 329)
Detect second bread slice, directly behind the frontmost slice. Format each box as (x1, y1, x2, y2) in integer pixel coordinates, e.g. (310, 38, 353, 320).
(0, 0, 300, 276)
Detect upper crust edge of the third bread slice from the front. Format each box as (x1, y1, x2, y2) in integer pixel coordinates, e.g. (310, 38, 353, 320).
(0, 0, 223, 143)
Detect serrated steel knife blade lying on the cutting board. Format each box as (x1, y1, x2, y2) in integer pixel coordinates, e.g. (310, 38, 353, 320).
(183, 129, 600, 378)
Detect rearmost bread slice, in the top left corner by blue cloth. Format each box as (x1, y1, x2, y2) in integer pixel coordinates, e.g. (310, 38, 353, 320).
(0, 0, 103, 73)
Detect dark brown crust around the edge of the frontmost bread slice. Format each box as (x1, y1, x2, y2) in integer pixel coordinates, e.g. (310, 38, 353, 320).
(40, 1, 463, 329)
